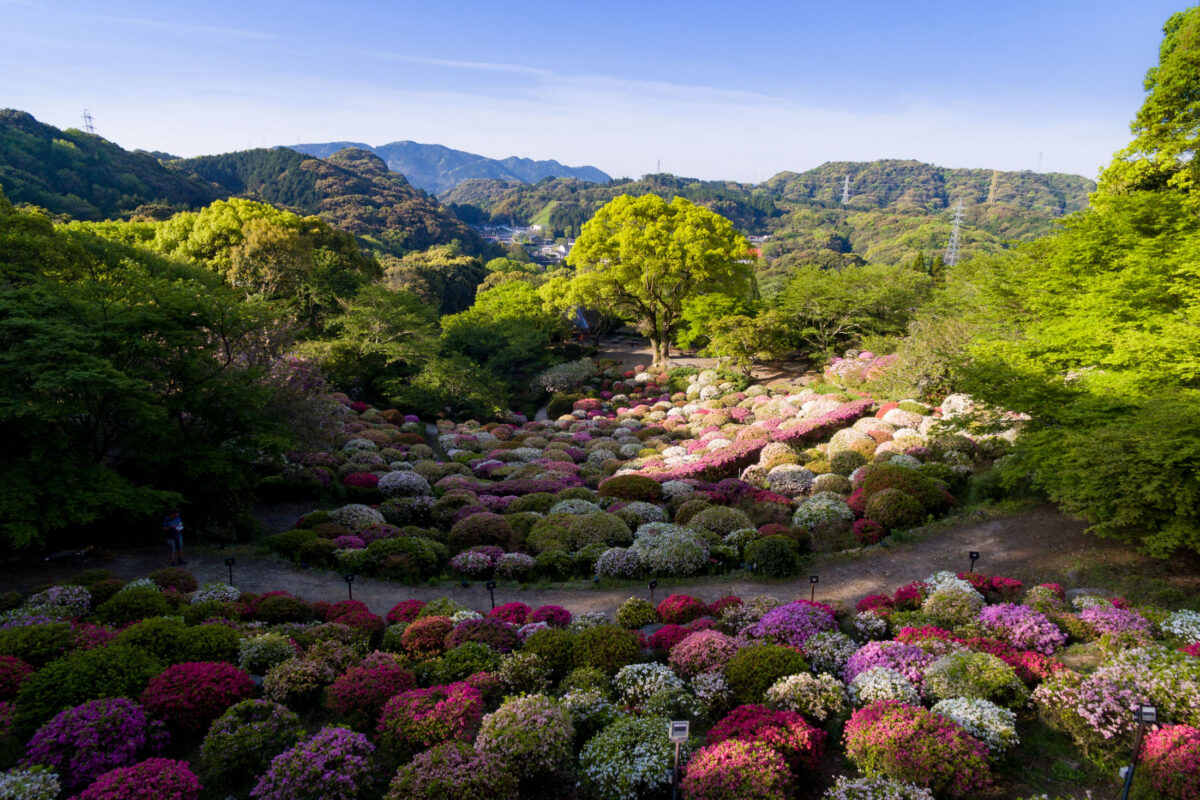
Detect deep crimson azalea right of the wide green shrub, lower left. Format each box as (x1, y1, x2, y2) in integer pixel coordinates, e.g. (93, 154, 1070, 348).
(142, 661, 254, 735)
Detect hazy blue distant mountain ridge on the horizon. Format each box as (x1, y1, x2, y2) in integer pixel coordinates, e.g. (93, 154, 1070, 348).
(284, 140, 612, 194)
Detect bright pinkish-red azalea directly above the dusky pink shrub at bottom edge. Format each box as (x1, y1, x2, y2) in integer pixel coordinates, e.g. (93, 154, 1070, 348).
(377, 681, 484, 752)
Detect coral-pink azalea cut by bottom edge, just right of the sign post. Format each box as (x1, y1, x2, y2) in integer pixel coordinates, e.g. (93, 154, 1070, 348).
(680, 739, 792, 800)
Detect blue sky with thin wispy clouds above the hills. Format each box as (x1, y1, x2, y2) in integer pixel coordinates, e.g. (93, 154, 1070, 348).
(0, 0, 1183, 181)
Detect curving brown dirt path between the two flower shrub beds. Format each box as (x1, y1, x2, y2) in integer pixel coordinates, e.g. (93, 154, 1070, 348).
(7, 506, 1196, 614)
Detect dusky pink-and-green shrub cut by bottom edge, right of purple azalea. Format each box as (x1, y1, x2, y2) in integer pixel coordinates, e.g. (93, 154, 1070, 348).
(384, 741, 517, 800)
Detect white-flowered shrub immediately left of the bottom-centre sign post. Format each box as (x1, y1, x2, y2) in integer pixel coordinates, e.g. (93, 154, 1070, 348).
(578, 716, 685, 800)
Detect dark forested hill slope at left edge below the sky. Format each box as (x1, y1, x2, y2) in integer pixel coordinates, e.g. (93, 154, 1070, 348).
(0, 108, 220, 219)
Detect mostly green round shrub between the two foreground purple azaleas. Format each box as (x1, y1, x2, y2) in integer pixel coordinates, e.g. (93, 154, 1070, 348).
(199, 700, 304, 789)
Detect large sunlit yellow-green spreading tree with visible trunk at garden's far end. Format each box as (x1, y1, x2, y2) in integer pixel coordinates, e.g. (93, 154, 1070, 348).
(568, 194, 754, 366)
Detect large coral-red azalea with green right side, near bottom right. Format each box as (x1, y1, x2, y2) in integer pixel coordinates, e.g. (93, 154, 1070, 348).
(844, 700, 992, 798)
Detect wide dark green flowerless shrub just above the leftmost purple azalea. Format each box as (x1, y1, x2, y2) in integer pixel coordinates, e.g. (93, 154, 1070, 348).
(14, 644, 163, 736)
